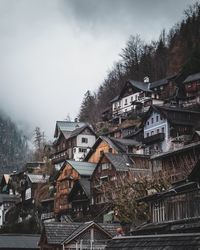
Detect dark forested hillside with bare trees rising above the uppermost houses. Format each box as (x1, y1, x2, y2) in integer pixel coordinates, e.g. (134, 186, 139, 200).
(79, 3, 200, 124)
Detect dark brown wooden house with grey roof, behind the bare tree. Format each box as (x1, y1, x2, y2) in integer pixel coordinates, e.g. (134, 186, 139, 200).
(91, 153, 151, 221)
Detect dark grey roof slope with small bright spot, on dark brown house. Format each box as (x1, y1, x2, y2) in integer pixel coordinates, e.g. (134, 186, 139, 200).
(105, 153, 132, 171)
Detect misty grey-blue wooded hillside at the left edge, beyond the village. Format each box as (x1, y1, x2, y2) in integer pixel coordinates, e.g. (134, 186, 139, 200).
(0, 112, 28, 173)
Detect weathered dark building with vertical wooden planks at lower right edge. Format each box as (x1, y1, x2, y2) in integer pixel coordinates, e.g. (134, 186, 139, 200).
(134, 160, 200, 234)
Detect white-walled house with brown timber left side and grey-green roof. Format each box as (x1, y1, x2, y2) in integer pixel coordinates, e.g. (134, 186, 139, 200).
(51, 121, 96, 168)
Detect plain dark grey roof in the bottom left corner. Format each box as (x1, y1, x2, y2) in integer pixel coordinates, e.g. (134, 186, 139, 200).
(0, 234, 40, 249)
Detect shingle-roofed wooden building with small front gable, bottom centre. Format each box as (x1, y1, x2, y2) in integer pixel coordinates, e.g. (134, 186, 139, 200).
(39, 221, 119, 250)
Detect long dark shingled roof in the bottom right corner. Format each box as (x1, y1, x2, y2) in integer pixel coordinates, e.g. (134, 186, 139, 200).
(106, 233, 200, 250)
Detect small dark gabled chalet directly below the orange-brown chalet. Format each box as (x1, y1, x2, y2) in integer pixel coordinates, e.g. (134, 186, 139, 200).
(68, 178, 91, 221)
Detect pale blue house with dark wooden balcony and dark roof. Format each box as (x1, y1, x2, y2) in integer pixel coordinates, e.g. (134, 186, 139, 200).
(141, 105, 200, 155)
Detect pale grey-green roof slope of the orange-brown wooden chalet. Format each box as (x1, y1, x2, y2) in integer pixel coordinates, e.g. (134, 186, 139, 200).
(66, 160, 96, 176)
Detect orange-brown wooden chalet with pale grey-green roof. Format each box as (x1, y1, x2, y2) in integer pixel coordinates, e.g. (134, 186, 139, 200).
(54, 160, 96, 215)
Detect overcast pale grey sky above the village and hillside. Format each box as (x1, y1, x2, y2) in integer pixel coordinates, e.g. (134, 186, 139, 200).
(0, 0, 195, 138)
